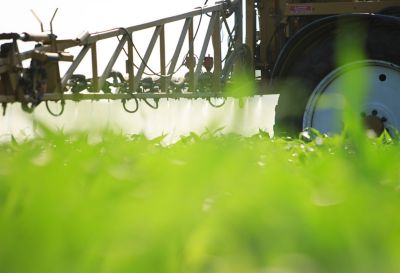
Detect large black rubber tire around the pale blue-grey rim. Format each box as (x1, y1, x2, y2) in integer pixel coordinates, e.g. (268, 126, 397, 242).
(272, 14, 400, 136)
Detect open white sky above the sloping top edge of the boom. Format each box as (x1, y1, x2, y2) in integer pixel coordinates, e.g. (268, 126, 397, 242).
(0, 0, 209, 38)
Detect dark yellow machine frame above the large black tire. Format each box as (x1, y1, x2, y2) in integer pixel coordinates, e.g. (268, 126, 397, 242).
(246, 0, 400, 81)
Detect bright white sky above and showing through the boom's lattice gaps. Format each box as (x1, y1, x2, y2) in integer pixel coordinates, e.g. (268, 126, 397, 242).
(0, 0, 227, 75)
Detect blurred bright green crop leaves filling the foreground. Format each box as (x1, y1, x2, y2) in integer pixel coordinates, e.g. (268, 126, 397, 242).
(0, 128, 400, 273)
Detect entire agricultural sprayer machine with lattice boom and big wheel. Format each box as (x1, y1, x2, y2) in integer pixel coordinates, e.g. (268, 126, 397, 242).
(0, 0, 400, 135)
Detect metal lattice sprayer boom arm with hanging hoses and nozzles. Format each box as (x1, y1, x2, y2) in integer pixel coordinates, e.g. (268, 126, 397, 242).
(0, 1, 241, 111)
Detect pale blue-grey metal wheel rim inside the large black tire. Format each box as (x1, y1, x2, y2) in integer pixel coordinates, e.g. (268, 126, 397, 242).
(303, 60, 400, 135)
